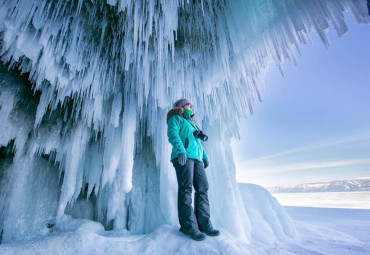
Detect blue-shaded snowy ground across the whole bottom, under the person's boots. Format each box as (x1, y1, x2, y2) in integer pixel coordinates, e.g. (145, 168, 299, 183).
(0, 195, 370, 255)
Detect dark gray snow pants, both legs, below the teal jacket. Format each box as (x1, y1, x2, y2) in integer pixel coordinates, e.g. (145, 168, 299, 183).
(172, 158, 212, 232)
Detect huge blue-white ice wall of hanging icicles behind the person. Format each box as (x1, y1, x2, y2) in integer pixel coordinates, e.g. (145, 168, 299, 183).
(0, 0, 369, 242)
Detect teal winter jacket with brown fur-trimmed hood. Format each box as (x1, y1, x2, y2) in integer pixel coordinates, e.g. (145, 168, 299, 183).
(167, 107, 207, 161)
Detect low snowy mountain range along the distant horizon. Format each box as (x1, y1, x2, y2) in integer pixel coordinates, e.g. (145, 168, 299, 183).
(267, 177, 370, 193)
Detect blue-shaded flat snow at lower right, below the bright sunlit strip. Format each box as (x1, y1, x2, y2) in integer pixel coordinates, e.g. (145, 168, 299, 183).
(285, 207, 370, 255)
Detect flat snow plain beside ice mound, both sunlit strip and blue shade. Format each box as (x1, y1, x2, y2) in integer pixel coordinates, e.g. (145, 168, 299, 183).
(273, 192, 370, 254)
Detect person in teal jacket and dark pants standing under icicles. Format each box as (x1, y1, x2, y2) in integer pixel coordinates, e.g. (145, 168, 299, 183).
(167, 99, 220, 241)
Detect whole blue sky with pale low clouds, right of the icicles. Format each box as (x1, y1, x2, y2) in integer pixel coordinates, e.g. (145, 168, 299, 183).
(231, 14, 370, 187)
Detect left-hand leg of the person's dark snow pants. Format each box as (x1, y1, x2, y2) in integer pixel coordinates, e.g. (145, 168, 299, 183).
(172, 159, 198, 232)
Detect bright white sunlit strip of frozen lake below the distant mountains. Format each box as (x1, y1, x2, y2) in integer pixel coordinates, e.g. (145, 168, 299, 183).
(272, 191, 370, 209)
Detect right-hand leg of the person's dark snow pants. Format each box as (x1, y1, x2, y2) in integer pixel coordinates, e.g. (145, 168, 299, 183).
(193, 160, 212, 230)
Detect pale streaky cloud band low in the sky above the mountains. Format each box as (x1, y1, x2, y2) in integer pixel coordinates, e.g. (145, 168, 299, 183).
(236, 133, 370, 187)
